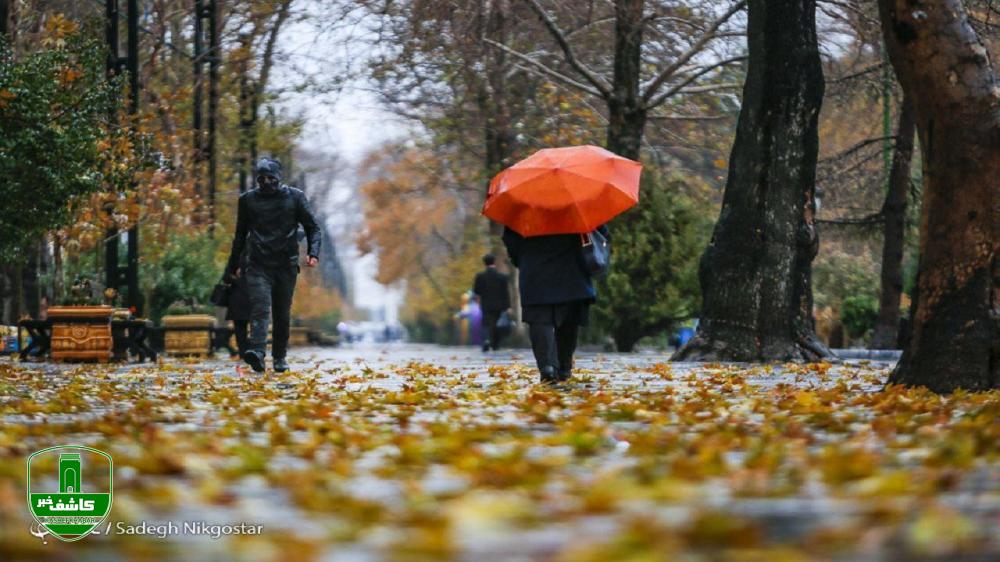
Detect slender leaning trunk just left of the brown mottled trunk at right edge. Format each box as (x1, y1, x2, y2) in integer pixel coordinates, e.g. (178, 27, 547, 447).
(871, 98, 916, 349)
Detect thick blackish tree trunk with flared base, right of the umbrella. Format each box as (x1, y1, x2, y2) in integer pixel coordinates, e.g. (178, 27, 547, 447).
(674, 0, 831, 361)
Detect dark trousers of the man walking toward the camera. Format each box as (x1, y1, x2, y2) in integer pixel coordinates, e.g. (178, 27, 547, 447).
(246, 265, 299, 359)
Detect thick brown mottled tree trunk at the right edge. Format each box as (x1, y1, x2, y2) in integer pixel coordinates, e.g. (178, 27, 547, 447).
(879, 0, 1000, 392)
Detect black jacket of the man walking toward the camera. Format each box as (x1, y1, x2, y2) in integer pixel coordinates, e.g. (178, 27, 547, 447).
(226, 185, 322, 272)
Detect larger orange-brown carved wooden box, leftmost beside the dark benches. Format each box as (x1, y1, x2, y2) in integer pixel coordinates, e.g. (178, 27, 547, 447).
(48, 306, 114, 363)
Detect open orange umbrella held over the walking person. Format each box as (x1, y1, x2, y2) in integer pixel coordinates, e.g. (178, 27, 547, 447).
(483, 146, 642, 236)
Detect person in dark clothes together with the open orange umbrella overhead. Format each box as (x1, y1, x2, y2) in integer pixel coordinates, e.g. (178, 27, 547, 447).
(483, 146, 642, 383)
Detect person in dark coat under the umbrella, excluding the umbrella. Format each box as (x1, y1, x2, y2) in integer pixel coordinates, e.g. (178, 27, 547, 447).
(503, 225, 611, 383)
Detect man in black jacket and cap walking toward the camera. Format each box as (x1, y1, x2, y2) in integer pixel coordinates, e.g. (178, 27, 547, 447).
(226, 158, 322, 373)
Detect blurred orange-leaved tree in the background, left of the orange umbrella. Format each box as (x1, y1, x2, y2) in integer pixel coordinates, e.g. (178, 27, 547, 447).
(357, 145, 487, 339)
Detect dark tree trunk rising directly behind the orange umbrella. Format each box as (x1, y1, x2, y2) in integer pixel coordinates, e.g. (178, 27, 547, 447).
(605, 0, 646, 160)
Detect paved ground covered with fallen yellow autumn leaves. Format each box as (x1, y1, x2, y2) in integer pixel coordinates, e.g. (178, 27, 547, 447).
(0, 347, 1000, 562)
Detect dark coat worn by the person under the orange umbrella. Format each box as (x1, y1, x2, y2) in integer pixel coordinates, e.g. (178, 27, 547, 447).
(503, 226, 611, 306)
